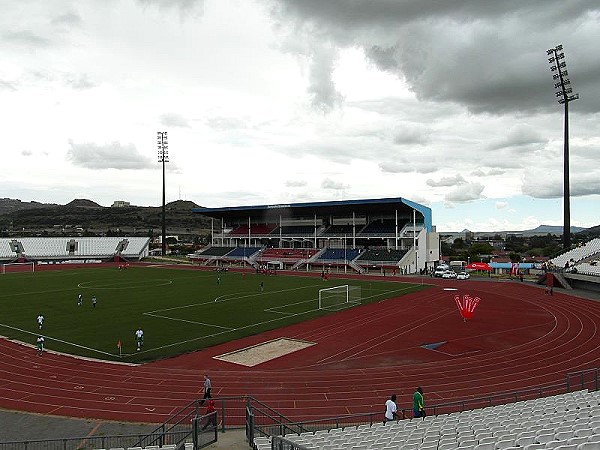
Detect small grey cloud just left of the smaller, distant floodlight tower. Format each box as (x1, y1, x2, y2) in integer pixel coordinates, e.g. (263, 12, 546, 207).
(67, 141, 156, 170)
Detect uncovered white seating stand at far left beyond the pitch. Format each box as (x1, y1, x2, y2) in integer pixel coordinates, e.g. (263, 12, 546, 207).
(0, 237, 150, 264)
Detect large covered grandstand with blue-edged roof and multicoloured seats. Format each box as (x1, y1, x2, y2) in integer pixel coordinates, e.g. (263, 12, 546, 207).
(189, 198, 440, 274)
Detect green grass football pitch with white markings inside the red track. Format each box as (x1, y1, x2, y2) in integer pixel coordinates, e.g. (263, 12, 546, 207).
(0, 266, 427, 362)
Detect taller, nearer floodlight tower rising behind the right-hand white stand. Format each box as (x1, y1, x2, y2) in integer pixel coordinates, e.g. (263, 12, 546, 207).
(546, 45, 579, 250)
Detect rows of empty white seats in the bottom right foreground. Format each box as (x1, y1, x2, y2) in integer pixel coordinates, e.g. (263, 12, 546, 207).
(254, 391, 600, 450)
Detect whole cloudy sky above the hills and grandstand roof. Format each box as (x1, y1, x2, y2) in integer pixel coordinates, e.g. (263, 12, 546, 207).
(0, 0, 600, 231)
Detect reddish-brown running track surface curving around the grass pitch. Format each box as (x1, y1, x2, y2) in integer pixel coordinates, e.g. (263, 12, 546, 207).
(0, 278, 600, 424)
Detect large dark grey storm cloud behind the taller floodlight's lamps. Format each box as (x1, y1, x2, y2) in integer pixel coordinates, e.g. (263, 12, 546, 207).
(269, 0, 600, 114)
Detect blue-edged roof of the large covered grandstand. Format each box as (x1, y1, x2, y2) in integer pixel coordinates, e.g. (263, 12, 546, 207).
(192, 197, 432, 231)
